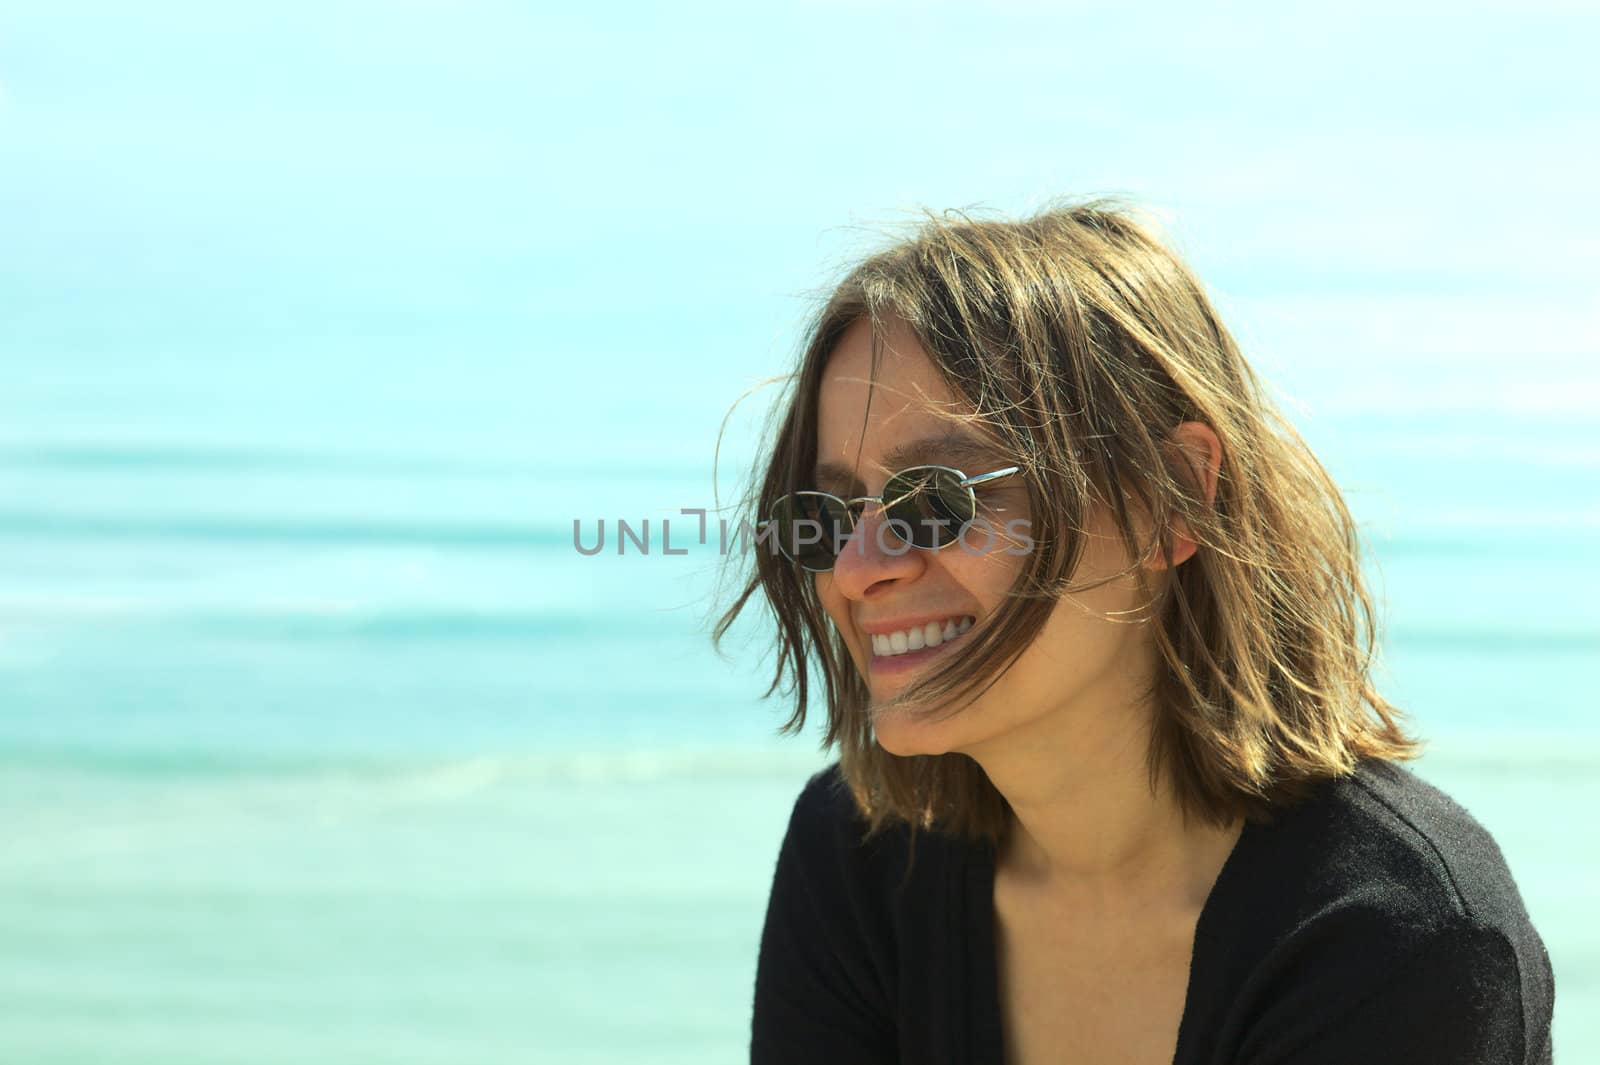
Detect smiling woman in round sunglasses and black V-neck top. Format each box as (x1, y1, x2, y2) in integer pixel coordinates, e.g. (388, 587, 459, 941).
(717, 200, 1554, 1065)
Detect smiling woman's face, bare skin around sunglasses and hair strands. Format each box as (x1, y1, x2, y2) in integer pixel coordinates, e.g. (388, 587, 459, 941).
(814, 320, 1154, 758)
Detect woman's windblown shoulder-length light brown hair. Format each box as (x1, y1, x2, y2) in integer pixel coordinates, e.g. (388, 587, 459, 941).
(712, 198, 1419, 843)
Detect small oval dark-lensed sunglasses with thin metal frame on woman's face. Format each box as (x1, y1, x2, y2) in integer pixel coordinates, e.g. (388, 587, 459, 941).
(757, 465, 1022, 572)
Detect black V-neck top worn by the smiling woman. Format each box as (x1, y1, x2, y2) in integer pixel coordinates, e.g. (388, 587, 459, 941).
(750, 760, 1554, 1065)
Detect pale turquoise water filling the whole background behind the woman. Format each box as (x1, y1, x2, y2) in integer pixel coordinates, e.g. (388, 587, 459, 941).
(0, 0, 1600, 1065)
